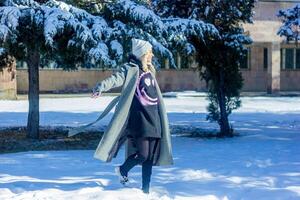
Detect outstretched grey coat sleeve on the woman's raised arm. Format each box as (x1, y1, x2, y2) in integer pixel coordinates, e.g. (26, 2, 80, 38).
(93, 65, 127, 92)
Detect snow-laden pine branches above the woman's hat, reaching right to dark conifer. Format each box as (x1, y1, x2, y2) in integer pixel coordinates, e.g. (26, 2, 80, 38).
(108, 0, 219, 67)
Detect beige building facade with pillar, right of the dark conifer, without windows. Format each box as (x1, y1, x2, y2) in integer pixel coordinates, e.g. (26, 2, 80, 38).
(242, 0, 300, 93)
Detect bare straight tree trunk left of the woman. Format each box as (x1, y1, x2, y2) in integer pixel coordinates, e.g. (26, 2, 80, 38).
(27, 47, 40, 139)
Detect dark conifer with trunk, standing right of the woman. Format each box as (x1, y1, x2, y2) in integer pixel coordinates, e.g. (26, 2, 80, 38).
(152, 0, 255, 136)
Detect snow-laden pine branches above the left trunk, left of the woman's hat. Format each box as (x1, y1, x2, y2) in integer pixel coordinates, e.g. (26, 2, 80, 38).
(0, 0, 116, 67)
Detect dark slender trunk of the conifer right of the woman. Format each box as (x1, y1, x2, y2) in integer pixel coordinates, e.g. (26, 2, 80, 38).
(218, 67, 232, 137)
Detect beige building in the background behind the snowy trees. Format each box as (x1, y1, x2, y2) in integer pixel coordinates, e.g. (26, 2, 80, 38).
(0, 0, 300, 98)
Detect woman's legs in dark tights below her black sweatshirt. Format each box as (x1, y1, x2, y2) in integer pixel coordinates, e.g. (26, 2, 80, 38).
(120, 138, 157, 188)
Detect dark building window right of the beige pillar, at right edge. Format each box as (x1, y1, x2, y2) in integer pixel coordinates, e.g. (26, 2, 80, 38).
(280, 48, 300, 70)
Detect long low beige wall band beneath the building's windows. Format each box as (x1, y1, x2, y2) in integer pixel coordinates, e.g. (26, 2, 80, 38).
(11, 69, 300, 93)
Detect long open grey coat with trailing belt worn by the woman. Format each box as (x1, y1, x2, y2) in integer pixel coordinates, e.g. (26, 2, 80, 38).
(68, 62, 173, 166)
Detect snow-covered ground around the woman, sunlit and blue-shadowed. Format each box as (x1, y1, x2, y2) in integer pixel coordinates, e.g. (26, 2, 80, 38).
(0, 95, 300, 200)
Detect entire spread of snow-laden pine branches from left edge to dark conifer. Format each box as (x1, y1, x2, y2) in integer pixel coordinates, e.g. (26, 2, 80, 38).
(0, 0, 218, 68)
